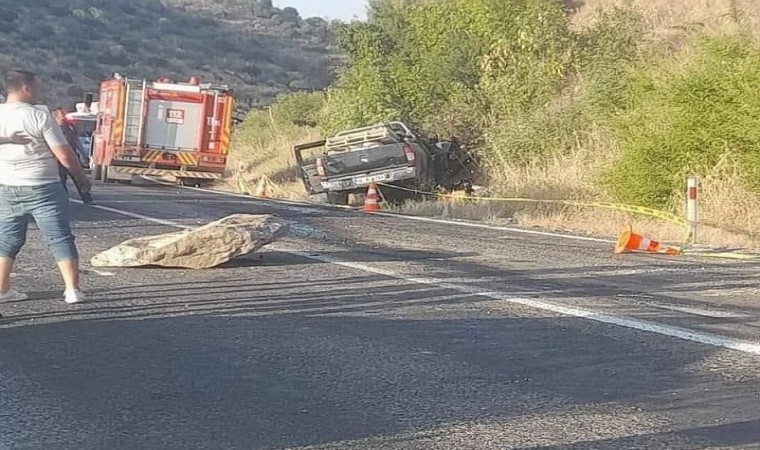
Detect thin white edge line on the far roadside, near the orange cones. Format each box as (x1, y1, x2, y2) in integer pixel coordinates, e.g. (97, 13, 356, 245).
(144, 179, 616, 244)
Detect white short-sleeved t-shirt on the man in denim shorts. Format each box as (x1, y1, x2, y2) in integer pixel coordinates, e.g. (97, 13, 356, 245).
(0, 103, 68, 186)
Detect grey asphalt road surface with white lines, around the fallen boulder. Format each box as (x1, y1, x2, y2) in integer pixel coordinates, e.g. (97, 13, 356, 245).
(0, 181, 760, 450)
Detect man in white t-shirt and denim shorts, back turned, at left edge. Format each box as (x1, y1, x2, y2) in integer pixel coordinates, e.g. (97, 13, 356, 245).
(0, 70, 90, 303)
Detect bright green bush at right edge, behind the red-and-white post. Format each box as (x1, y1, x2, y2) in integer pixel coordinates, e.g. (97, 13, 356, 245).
(602, 36, 760, 207)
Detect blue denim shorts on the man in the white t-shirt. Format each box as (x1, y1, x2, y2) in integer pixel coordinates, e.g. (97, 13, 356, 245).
(0, 182, 79, 262)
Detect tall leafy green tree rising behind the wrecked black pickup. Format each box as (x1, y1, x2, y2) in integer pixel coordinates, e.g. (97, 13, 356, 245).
(322, 0, 571, 133)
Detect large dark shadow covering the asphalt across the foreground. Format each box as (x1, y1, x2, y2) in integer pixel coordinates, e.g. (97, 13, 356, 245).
(0, 308, 758, 449)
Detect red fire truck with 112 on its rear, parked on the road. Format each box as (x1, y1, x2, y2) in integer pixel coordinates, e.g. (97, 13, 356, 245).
(92, 74, 235, 186)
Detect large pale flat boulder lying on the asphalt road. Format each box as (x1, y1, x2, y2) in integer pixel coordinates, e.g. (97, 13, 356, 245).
(90, 214, 289, 269)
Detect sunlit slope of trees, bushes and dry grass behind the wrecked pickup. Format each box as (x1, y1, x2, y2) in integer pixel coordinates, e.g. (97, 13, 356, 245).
(233, 0, 760, 248)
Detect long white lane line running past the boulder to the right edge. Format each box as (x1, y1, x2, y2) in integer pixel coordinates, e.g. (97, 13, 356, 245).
(75, 199, 760, 356)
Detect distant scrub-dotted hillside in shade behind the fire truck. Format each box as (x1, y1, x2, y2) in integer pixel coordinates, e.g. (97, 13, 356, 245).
(0, 0, 337, 109)
